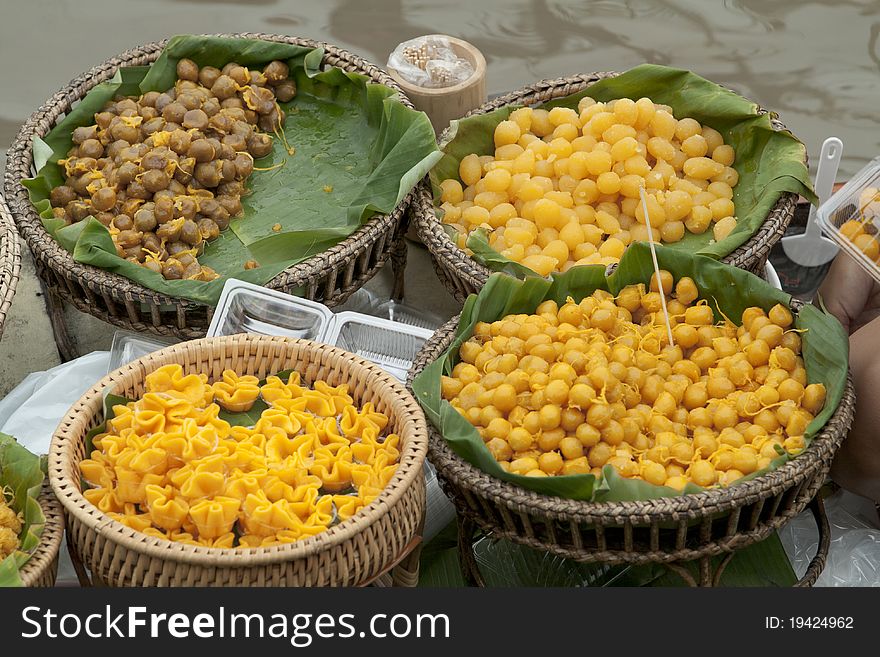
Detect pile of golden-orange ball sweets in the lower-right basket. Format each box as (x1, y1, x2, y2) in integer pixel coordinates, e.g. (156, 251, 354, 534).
(441, 271, 825, 490)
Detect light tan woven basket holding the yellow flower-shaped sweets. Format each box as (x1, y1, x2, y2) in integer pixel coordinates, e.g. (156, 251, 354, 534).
(49, 334, 427, 586)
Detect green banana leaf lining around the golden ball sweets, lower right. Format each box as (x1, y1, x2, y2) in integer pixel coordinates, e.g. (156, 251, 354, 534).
(412, 242, 849, 501)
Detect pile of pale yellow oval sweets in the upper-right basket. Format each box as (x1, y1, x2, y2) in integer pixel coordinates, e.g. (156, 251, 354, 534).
(440, 97, 739, 276)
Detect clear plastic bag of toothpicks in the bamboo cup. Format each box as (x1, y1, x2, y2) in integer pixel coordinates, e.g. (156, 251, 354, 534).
(388, 36, 474, 89)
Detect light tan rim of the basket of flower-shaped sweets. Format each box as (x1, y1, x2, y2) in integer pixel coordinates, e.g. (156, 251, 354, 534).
(48, 334, 428, 568)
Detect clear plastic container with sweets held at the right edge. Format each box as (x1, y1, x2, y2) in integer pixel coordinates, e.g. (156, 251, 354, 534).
(817, 157, 880, 282)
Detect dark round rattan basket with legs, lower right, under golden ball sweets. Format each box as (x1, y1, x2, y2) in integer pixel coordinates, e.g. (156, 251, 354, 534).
(408, 302, 855, 584)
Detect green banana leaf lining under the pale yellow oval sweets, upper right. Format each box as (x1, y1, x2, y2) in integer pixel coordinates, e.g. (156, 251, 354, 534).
(431, 64, 817, 275)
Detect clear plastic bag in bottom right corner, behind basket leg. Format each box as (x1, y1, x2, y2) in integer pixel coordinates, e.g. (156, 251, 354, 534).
(779, 491, 880, 587)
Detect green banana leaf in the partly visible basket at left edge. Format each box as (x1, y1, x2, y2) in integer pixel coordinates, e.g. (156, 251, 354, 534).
(0, 433, 46, 587)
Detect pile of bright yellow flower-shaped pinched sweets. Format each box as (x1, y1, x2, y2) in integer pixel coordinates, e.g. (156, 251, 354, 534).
(80, 365, 400, 548)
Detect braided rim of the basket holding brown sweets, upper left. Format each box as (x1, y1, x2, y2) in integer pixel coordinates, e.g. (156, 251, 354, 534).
(4, 32, 421, 309)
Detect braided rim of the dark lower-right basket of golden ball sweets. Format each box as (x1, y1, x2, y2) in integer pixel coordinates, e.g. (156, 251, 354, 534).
(407, 304, 855, 525)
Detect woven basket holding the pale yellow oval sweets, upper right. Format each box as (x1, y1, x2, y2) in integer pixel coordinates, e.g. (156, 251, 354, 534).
(413, 73, 797, 302)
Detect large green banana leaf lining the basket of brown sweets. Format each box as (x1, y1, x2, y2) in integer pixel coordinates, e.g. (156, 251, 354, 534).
(24, 35, 440, 305)
